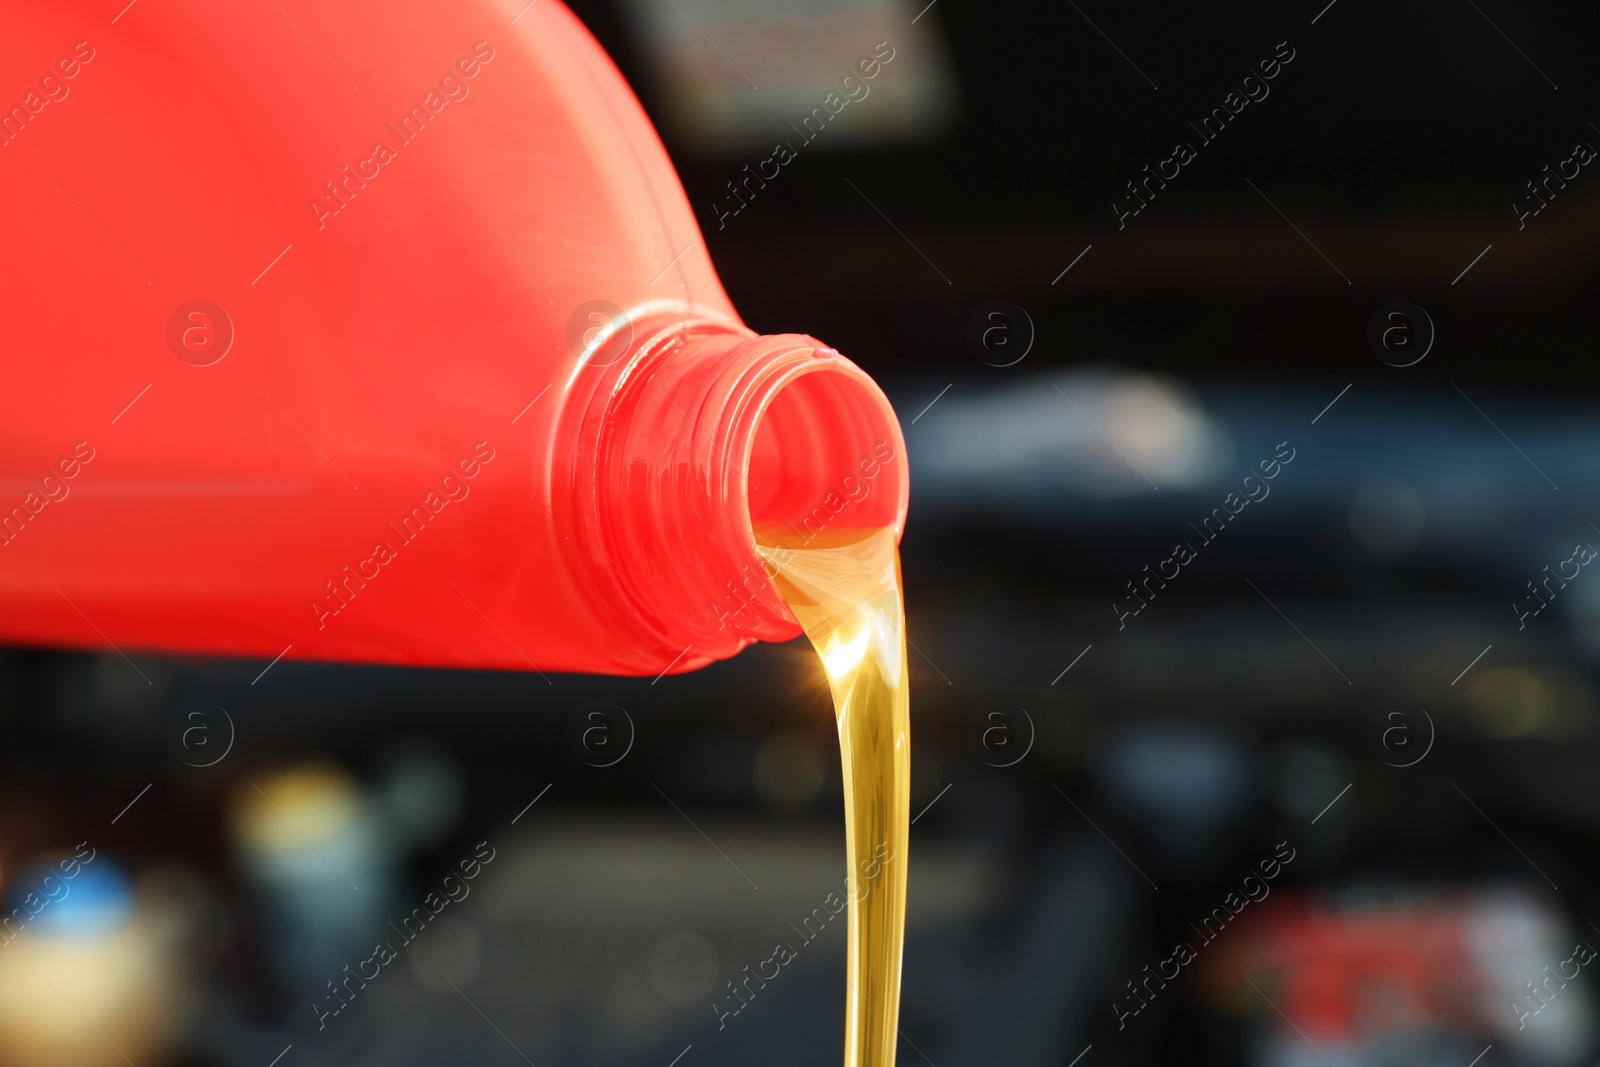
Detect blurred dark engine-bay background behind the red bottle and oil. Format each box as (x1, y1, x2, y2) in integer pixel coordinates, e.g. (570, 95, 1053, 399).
(0, 0, 1600, 1067)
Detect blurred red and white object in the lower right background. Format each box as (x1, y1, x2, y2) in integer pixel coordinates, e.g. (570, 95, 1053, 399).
(1200, 888, 1594, 1064)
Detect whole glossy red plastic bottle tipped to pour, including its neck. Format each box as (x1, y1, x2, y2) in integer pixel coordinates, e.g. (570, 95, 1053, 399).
(0, 0, 907, 675)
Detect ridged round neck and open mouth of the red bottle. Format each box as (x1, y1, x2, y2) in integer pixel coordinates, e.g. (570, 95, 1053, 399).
(552, 318, 909, 670)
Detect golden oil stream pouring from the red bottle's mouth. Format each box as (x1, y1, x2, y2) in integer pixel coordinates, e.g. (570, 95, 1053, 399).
(757, 528, 910, 1067)
